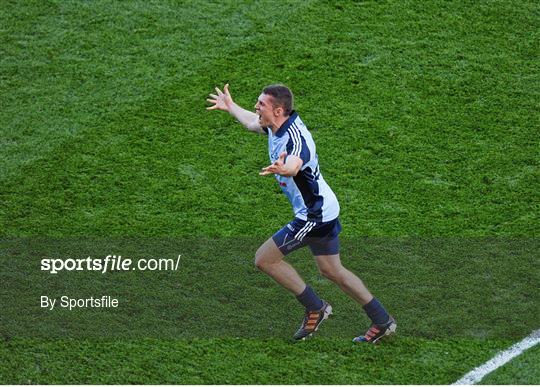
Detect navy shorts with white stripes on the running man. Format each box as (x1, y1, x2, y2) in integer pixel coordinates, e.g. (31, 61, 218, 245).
(272, 218, 341, 255)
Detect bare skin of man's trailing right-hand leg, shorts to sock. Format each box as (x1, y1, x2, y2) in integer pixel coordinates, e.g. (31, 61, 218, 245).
(315, 254, 373, 305)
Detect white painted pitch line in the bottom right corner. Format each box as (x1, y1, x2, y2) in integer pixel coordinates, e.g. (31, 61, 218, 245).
(454, 329, 540, 384)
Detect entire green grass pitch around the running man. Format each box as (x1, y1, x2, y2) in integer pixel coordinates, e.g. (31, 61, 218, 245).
(0, 0, 540, 384)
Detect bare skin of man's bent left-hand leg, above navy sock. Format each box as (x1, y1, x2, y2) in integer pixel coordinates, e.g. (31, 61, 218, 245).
(255, 238, 306, 296)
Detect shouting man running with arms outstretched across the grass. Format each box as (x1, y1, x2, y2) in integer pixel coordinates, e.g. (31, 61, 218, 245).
(207, 84, 396, 343)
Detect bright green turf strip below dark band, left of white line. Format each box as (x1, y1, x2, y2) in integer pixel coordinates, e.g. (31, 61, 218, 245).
(0, 338, 508, 384)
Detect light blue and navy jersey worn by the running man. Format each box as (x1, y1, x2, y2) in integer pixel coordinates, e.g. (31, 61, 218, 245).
(265, 112, 339, 222)
